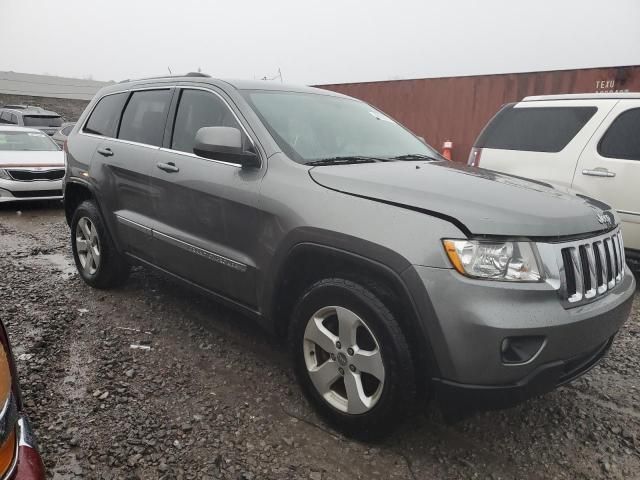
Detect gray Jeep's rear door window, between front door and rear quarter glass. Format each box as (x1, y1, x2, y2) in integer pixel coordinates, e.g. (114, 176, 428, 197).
(118, 89, 171, 147)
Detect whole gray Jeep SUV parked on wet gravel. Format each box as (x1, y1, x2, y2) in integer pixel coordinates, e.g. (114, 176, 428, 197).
(65, 74, 635, 438)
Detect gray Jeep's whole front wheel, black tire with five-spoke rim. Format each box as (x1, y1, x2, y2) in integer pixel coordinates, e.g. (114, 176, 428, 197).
(289, 278, 416, 440)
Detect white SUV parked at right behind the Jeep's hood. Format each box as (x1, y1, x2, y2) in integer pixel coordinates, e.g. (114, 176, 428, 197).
(468, 93, 640, 270)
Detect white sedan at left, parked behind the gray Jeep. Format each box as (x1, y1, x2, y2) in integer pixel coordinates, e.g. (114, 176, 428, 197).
(0, 125, 65, 202)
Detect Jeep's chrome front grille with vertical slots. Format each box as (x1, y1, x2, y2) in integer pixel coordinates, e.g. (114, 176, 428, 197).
(561, 229, 625, 304)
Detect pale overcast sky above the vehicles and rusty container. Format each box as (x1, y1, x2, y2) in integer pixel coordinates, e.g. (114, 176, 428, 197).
(0, 0, 640, 84)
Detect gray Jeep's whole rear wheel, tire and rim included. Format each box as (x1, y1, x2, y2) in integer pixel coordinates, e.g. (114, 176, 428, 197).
(71, 200, 129, 289)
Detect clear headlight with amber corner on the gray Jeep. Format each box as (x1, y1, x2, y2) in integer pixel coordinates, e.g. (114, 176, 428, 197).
(443, 240, 542, 282)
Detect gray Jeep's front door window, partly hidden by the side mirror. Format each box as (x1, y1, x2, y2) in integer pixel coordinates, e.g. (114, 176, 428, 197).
(171, 89, 248, 153)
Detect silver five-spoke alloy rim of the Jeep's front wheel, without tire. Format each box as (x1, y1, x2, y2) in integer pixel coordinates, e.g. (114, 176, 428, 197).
(303, 306, 385, 415)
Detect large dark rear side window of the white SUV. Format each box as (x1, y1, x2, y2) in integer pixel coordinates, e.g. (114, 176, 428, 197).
(475, 105, 598, 152)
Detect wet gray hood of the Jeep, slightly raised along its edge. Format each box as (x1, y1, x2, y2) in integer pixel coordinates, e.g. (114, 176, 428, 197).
(309, 162, 618, 237)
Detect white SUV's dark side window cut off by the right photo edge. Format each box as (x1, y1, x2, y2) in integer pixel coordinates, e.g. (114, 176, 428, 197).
(598, 108, 640, 160)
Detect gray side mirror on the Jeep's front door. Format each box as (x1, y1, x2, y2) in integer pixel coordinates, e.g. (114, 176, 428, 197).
(193, 127, 260, 167)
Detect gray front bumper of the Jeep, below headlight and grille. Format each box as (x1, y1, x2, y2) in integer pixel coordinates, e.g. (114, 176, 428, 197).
(405, 266, 635, 409)
